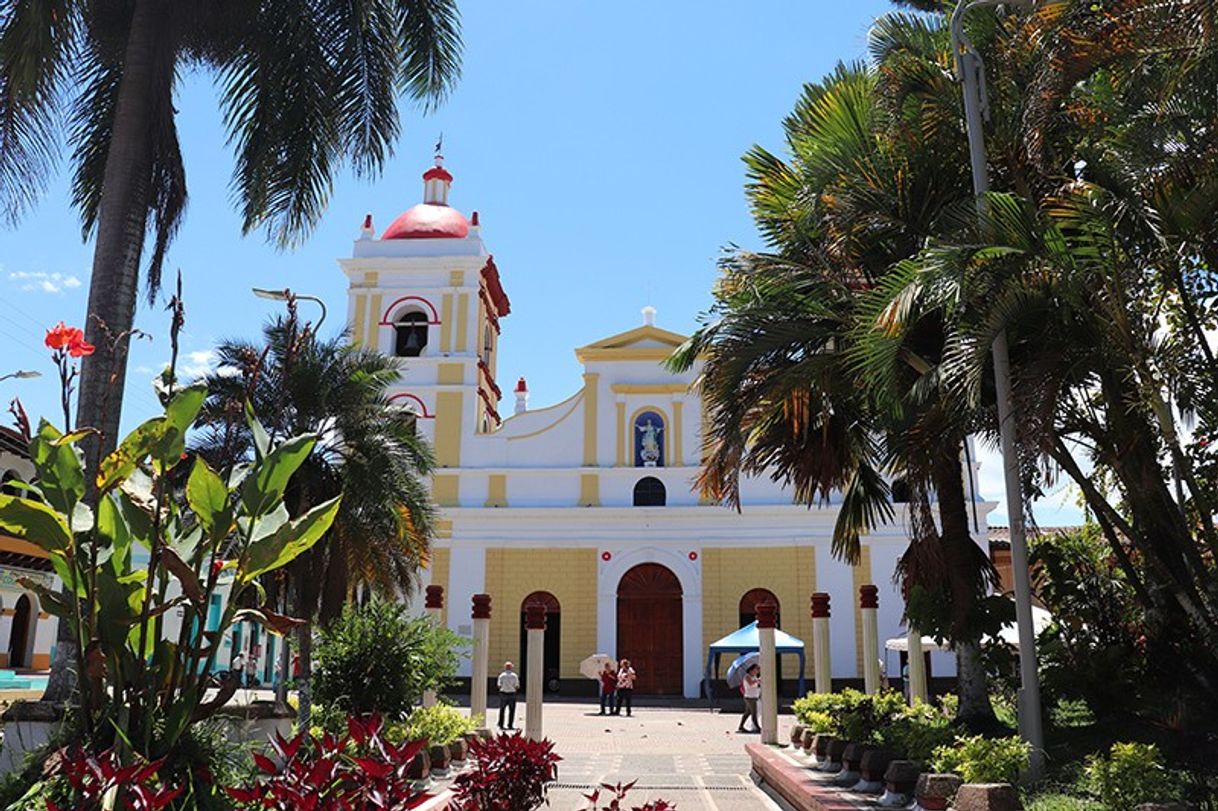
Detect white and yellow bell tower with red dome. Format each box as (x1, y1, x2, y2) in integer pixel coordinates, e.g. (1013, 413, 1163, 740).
(339, 155, 510, 474)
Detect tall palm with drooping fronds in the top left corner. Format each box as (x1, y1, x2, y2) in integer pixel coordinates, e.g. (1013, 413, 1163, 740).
(0, 0, 462, 700)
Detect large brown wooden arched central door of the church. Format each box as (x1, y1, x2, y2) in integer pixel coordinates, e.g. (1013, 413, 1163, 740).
(618, 564, 685, 695)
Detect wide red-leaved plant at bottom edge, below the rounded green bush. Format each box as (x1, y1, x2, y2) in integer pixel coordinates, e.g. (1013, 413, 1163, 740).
(224, 716, 428, 811)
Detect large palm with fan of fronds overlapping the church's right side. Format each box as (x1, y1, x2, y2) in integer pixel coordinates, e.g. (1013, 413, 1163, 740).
(674, 41, 994, 725)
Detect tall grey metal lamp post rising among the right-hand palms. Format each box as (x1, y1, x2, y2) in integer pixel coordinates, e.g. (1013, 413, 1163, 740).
(951, 0, 1045, 779)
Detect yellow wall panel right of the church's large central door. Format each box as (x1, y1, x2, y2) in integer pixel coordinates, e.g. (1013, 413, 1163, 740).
(702, 544, 816, 678)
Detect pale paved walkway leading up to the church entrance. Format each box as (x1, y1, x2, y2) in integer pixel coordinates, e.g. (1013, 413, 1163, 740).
(490, 697, 778, 811)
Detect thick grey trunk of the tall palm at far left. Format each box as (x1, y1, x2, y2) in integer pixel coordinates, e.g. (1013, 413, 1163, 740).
(43, 0, 160, 703)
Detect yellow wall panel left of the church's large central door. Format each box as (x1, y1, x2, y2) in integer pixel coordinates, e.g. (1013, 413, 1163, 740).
(486, 549, 597, 678)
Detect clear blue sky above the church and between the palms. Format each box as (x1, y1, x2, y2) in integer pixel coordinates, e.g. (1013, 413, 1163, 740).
(0, 0, 1077, 524)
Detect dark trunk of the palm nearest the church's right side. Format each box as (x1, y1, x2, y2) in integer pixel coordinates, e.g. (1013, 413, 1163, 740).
(934, 444, 996, 727)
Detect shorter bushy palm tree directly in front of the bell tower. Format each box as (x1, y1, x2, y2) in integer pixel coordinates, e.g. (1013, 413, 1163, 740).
(197, 308, 435, 718)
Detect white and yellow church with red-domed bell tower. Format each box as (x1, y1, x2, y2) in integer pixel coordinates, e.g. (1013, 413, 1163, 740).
(339, 157, 994, 698)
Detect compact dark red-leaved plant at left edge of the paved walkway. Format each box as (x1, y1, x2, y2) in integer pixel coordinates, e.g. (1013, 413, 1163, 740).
(453, 733, 563, 811)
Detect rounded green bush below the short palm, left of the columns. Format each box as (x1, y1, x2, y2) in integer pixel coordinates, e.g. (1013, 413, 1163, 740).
(313, 600, 466, 720)
